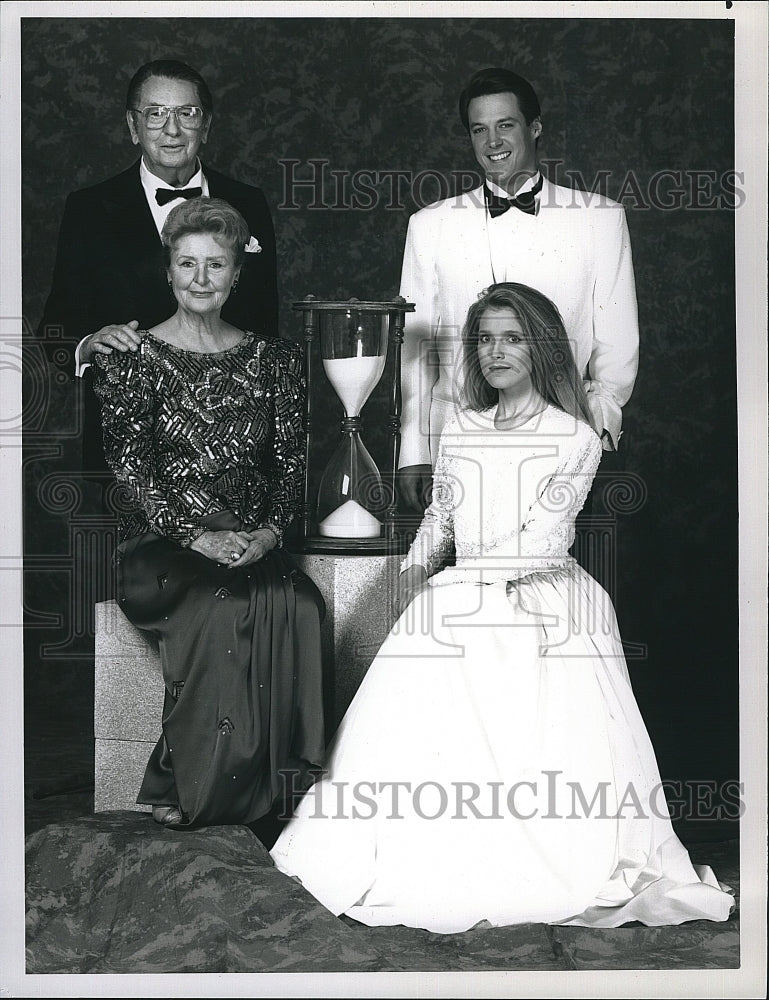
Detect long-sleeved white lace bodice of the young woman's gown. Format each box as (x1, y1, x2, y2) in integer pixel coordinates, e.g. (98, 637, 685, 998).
(402, 406, 601, 584)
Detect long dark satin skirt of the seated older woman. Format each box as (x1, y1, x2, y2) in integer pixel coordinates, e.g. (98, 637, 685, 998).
(117, 532, 324, 827)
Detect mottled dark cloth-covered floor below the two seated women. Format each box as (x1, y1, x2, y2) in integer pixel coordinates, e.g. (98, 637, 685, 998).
(25, 684, 740, 973)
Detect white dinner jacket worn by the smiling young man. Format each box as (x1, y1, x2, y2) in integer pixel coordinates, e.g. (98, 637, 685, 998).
(399, 178, 638, 468)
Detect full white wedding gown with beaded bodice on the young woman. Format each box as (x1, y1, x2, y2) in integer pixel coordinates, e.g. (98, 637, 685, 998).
(271, 407, 733, 933)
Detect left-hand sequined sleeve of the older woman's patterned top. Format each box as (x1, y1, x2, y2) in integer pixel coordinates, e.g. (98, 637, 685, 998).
(94, 345, 221, 546)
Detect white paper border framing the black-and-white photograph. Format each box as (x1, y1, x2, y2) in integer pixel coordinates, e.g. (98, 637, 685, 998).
(0, 0, 767, 997)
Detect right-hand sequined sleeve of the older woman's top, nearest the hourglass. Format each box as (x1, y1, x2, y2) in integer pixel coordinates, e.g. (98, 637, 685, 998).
(248, 341, 306, 542)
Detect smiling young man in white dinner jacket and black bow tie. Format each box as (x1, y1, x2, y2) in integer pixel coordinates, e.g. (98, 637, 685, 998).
(399, 68, 638, 509)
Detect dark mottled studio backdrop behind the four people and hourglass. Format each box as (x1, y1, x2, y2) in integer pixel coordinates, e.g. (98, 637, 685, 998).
(22, 19, 736, 824)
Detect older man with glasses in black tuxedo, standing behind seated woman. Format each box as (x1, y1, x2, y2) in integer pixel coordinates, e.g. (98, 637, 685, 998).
(38, 60, 278, 481)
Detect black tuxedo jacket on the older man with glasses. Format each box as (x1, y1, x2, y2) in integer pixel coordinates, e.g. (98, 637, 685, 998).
(38, 160, 278, 477)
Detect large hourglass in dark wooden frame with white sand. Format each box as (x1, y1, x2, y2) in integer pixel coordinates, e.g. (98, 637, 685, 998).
(294, 296, 414, 553)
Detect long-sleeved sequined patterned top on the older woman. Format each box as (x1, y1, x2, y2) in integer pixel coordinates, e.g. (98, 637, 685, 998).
(94, 333, 305, 545)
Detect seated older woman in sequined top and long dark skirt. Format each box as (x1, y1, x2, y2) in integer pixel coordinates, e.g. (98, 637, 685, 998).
(95, 198, 323, 827)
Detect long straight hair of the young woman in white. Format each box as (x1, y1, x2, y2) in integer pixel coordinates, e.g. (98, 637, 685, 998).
(462, 281, 600, 433)
